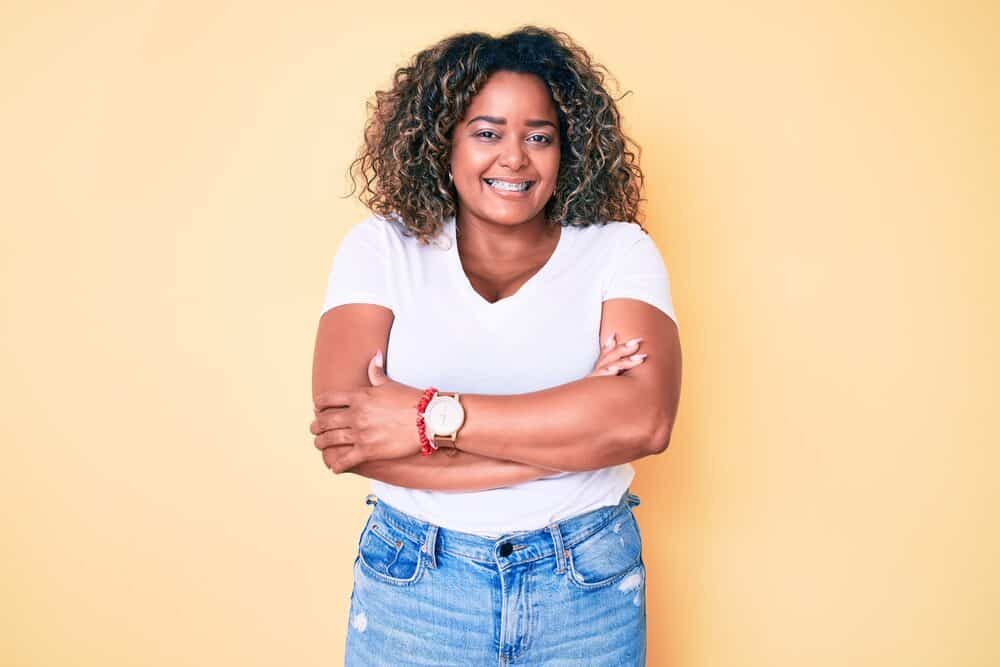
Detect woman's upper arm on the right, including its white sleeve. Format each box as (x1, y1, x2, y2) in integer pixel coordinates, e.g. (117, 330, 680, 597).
(600, 223, 681, 452)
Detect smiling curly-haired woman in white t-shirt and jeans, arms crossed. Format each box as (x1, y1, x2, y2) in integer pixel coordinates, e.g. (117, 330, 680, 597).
(310, 27, 681, 667)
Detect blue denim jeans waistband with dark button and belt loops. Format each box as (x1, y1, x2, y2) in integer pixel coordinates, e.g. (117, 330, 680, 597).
(365, 489, 640, 572)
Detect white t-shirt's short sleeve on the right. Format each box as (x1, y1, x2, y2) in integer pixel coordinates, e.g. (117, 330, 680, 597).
(601, 230, 680, 330)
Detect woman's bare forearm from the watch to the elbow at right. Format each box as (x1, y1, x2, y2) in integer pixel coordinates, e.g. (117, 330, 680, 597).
(450, 375, 664, 471)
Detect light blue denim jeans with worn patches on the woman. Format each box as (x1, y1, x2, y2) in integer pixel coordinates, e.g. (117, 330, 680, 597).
(344, 491, 646, 667)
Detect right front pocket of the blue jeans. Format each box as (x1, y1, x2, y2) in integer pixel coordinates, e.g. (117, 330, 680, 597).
(566, 507, 642, 590)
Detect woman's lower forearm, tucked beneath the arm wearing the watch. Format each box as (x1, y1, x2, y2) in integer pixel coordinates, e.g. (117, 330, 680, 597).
(347, 449, 559, 491)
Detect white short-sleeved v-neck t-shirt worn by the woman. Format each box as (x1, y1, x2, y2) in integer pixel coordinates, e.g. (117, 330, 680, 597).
(322, 216, 676, 538)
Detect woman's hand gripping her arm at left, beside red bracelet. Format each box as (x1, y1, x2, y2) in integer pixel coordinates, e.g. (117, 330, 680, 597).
(309, 350, 423, 474)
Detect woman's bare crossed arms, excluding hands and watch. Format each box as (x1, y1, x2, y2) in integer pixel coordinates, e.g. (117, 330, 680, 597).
(313, 298, 681, 491)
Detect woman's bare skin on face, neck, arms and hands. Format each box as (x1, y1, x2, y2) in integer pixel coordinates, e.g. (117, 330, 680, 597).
(310, 72, 680, 490)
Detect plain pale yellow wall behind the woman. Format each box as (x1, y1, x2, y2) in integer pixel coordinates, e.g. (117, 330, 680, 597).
(0, 0, 1000, 667)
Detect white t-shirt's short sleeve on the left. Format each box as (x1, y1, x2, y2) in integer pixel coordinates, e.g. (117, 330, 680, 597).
(320, 219, 396, 315)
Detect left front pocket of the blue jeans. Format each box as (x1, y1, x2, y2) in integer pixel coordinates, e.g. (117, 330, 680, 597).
(357, 512, 425, 586)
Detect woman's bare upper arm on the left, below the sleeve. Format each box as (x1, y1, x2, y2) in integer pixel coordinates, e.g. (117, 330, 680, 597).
(312, 303, 393, 402)
